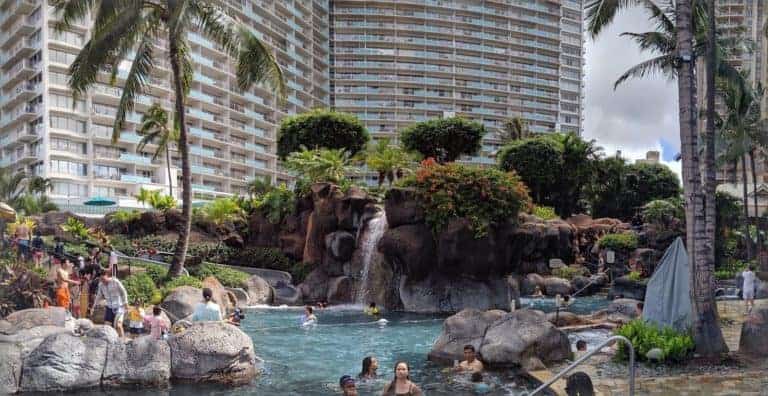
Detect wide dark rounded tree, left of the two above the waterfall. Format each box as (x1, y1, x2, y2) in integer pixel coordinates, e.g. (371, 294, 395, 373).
(277, 109, 370, 159)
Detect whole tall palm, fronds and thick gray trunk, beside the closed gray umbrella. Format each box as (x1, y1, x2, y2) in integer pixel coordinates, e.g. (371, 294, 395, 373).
(585, 0, 728, 357)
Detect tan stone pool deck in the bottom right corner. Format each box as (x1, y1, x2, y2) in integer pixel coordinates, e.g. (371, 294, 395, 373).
(552, 300, 768, 396)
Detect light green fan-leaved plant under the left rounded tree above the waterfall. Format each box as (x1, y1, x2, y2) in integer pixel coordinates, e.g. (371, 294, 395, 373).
(284, 149, 354, 184)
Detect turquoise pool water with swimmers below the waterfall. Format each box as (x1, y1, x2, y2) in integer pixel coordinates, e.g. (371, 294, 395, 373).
(78, 297, 604, 396)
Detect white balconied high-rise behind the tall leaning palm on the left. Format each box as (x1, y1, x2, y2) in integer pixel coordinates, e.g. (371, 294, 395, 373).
(0, 0, 329, 210)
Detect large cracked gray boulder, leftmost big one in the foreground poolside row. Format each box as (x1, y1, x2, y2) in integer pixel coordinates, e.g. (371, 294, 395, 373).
(20, 326, 120, 392)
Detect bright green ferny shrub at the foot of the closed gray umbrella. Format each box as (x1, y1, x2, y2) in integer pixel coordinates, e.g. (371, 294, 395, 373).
(616, 319, 695, 362)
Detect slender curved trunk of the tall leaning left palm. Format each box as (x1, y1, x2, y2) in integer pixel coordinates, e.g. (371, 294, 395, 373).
(169, 44, 192, 277)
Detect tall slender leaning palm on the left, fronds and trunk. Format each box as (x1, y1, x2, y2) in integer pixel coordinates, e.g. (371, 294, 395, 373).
(52, 0, 287, 276)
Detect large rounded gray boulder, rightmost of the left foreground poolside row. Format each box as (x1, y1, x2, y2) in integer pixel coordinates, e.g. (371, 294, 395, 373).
(168, 322, 257, 384)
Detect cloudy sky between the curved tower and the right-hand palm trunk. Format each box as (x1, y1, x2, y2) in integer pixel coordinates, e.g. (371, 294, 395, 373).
(584, 9, 680, 174)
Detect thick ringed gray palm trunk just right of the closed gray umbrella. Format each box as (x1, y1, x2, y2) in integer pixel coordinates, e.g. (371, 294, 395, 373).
(676, 0, 728, 357)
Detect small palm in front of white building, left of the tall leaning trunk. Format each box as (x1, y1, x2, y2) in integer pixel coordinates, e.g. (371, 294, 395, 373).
(136, 103, 179, 196)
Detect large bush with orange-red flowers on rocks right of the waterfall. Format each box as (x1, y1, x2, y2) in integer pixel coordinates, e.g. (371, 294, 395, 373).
(403, 160, 530, 238)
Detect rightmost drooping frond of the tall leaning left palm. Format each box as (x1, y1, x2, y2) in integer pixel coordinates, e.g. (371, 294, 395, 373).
(237, 28, 288, 102)
